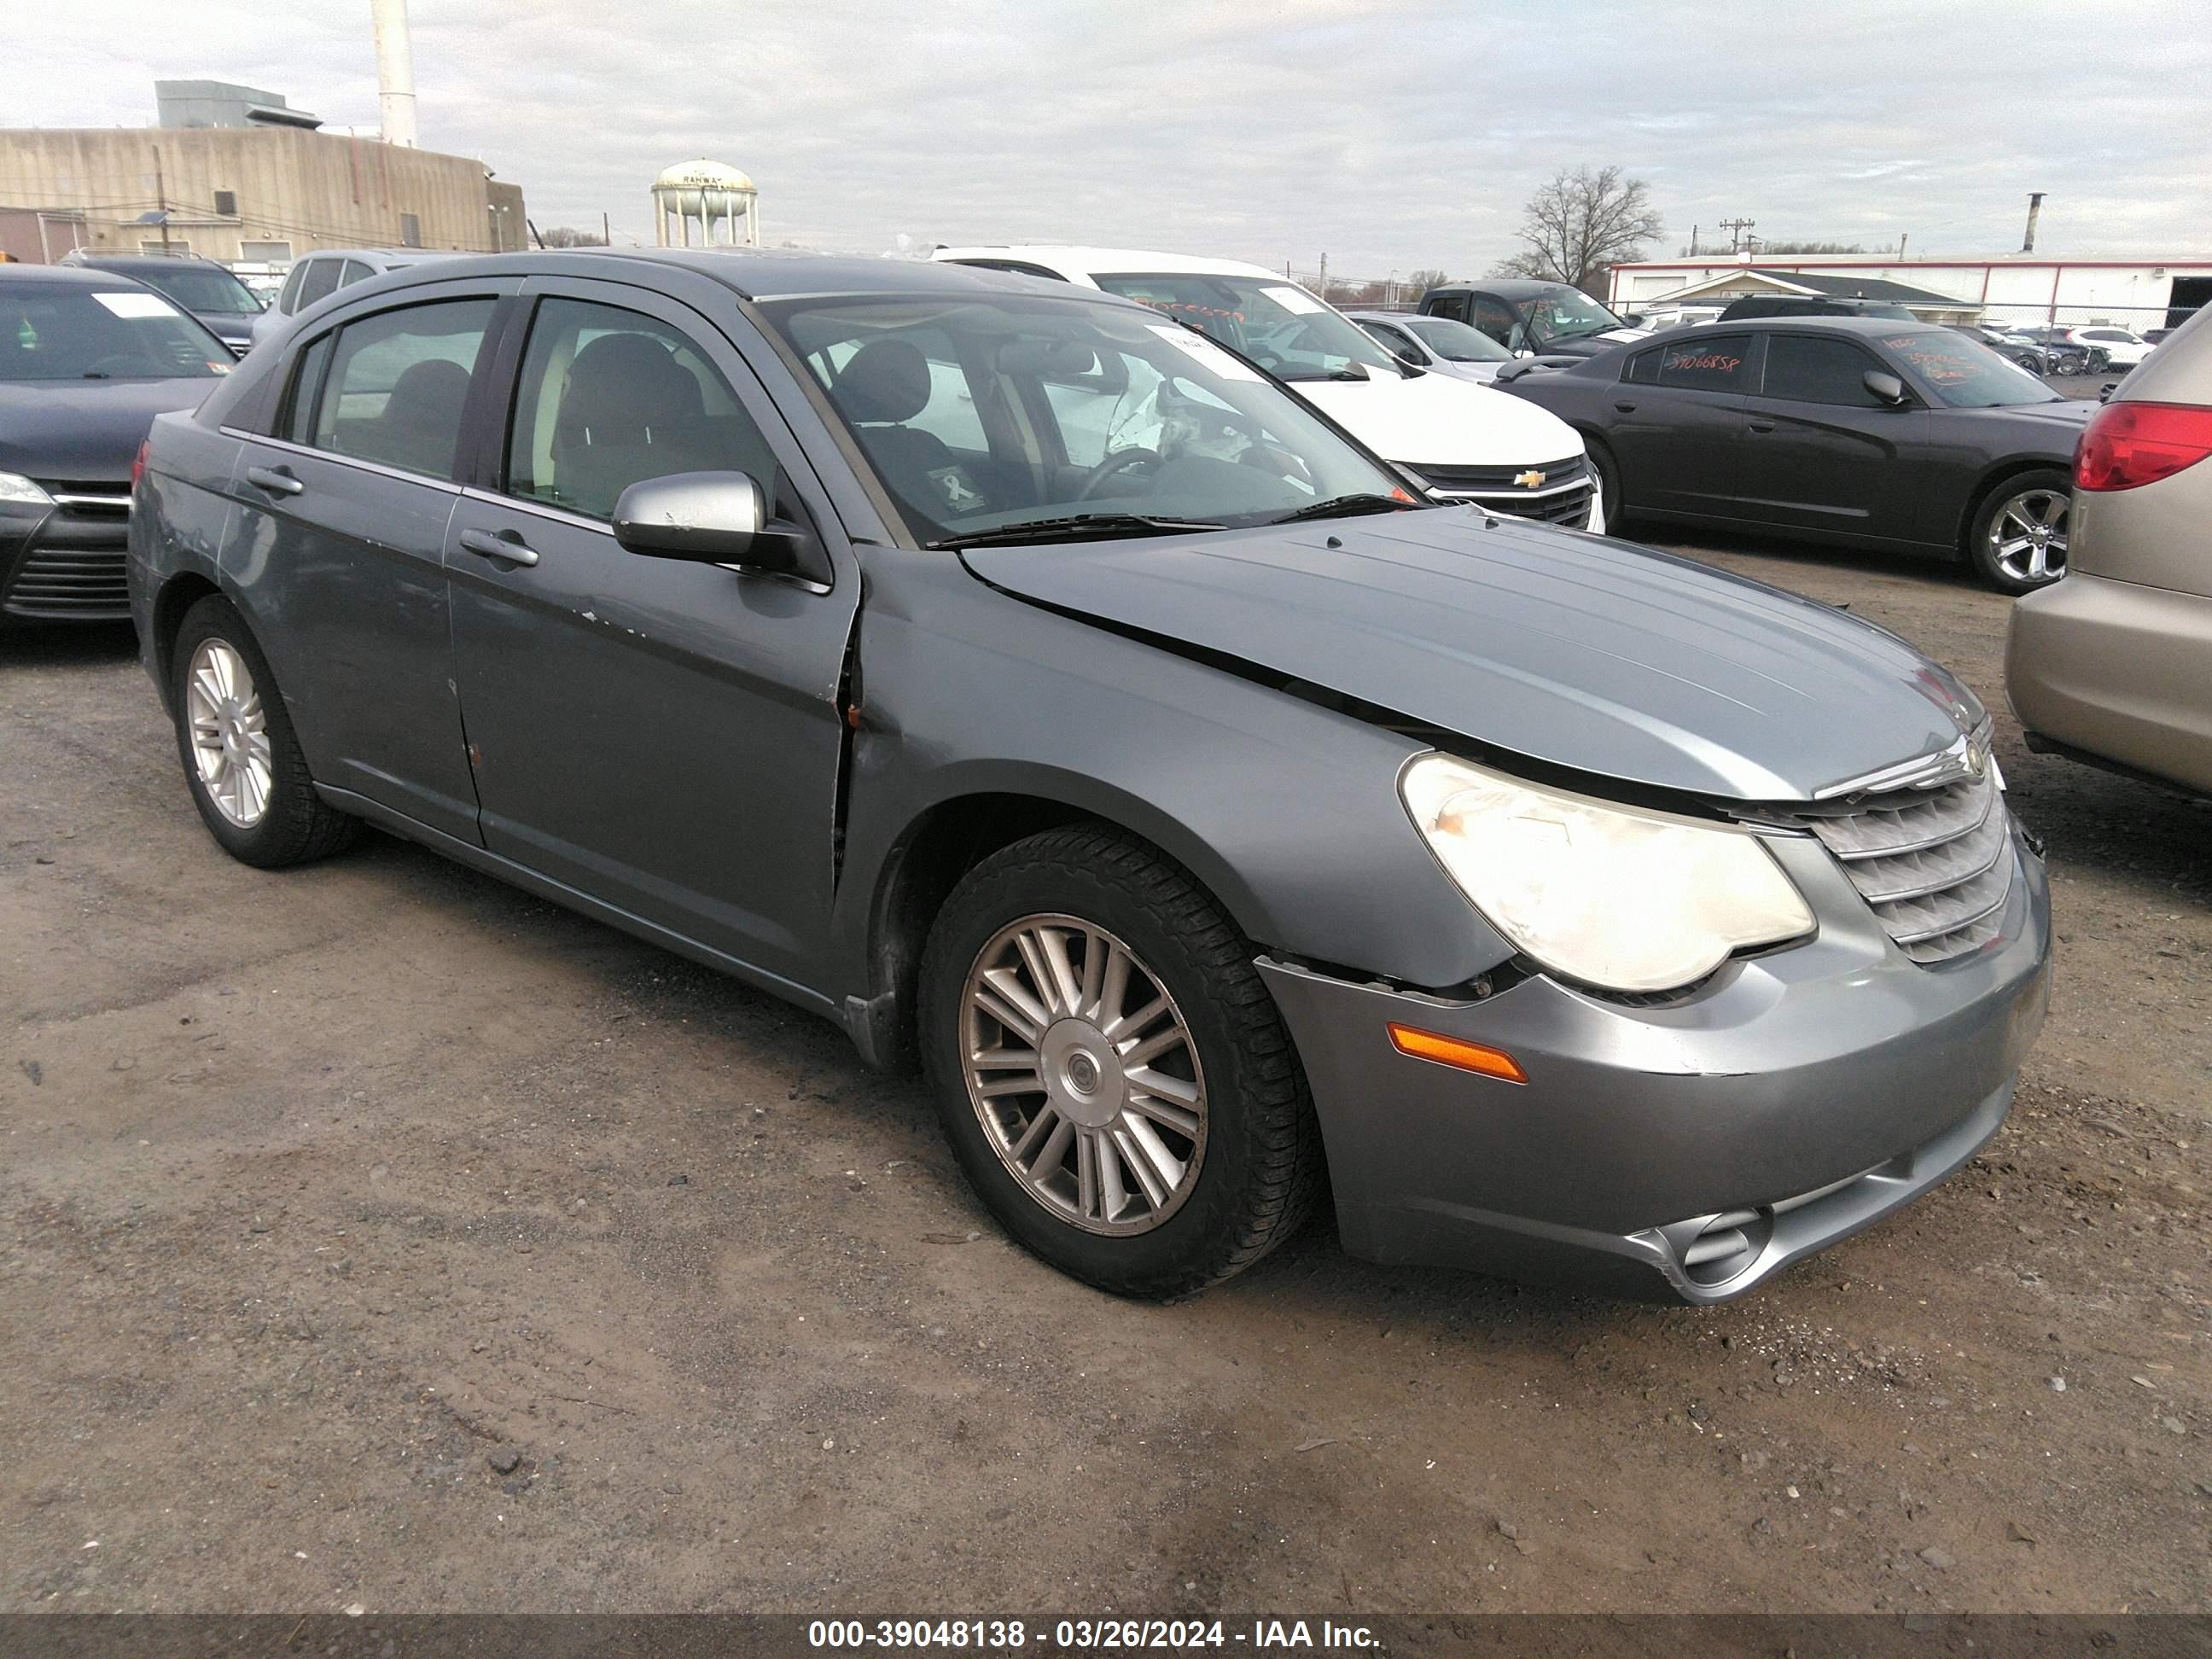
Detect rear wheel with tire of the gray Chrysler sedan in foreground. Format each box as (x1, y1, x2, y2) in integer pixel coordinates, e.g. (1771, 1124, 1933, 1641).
(168, 593, 360, 870)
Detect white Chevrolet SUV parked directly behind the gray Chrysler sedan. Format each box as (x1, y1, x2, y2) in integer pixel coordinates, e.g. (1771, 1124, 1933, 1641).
(934, 246, 1606, 531)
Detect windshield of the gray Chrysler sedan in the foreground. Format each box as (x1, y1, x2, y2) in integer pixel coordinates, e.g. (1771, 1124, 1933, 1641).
(761, 294, 1412, 542)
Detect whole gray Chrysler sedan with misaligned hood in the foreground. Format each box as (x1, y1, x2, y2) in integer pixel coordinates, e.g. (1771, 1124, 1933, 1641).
(133, 252, 2051, 1301)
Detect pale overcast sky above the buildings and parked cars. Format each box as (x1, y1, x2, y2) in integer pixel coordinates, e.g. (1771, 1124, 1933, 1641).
(0, 0, 2212, 276)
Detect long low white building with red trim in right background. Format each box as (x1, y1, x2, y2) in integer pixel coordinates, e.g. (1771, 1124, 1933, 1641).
(1610, 254, 2212, 332)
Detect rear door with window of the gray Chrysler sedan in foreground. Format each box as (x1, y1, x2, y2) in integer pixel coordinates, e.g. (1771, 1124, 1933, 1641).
(221, 279, 520, 841)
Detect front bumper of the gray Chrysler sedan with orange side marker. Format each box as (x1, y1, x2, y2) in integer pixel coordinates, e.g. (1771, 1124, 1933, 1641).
(1259, 830, 2051, 1303)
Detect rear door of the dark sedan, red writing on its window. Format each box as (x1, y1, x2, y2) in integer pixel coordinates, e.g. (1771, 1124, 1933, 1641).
(1606, 329, 1761, 520)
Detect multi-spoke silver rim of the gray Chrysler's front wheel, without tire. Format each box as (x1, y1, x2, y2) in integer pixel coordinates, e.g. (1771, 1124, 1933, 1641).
(960, 916, 1206, 1234)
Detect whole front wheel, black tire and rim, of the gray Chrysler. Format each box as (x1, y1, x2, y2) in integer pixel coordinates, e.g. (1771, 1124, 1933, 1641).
(920, 825, 1320, 1299)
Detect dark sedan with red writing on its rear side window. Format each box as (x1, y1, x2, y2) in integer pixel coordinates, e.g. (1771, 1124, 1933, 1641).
(1498, 317, 2097, 593)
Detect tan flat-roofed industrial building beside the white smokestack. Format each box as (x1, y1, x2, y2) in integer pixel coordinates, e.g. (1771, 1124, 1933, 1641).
(0, 82, 528, 265)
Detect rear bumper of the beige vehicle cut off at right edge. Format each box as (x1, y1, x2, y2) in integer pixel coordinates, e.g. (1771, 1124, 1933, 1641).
(2004, 571, 2212, 795)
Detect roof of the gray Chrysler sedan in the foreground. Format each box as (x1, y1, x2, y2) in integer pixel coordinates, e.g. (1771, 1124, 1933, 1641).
(320, 247, 1124, 303)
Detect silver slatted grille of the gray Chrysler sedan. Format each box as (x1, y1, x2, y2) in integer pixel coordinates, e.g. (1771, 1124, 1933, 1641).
(1790, 767, 2017, 963)
